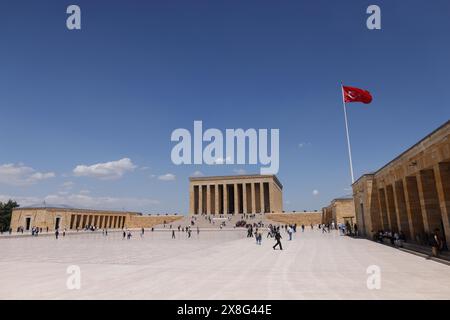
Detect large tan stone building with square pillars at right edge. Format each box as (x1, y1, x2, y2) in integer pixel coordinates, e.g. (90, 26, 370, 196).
(353, 121, 450, 247)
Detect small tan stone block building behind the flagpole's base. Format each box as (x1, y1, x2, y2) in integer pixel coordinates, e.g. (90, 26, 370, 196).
(322, 198, 356, 227)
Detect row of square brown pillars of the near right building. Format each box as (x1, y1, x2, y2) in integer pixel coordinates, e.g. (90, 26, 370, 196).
(360, 162, 450, 243)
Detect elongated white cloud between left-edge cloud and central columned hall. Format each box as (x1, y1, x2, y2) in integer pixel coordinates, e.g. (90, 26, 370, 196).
(73, 158, 136, 180)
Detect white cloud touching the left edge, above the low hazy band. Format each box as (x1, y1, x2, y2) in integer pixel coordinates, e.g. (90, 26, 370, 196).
(0, 163, 55, 186)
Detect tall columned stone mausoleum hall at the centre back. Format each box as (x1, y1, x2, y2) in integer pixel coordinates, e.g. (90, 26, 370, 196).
(189, 175, 283, 214)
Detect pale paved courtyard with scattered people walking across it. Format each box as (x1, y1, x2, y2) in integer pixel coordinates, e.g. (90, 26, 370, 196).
(0, 230, 450, 299)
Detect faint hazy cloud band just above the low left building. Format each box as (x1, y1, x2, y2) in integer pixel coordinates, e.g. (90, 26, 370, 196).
(0, 194, 160, 211)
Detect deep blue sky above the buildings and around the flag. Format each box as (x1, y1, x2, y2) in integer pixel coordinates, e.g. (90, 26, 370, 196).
(0, 0, 450, 213)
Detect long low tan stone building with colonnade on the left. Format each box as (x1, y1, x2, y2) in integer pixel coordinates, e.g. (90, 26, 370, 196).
(11, 207, 182, 231)
